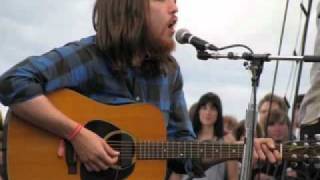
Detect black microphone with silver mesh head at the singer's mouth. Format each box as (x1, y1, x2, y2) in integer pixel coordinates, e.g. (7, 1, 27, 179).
(176, 29, 219, 51)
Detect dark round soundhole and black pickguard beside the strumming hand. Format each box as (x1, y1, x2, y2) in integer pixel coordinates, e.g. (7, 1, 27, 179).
(80, 120, 135, 180)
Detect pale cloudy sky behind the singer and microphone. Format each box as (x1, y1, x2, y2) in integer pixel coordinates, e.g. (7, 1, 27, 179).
(0, 0, 319, 120)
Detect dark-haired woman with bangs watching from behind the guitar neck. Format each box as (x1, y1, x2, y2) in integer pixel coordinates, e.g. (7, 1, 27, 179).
(184, 92, 238, 180)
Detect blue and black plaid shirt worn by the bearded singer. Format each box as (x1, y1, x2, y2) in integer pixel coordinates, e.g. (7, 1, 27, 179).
(0, 36, 200, 176)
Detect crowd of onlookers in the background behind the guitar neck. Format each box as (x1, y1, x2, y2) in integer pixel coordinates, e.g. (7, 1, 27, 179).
(181, 92, 304, 180)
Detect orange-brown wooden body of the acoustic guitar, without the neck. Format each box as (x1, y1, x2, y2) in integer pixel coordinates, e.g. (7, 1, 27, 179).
(4, 90, 166, 180)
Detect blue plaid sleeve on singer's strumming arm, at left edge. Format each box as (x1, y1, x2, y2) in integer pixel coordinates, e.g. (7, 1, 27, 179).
(0, 43, 92, 106)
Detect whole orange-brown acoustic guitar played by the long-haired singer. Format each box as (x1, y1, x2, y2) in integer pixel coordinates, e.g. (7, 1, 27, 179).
(4, 90, 320, 180)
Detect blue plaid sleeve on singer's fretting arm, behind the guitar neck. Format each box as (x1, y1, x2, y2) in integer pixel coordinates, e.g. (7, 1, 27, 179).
(167, 60, 204, 177)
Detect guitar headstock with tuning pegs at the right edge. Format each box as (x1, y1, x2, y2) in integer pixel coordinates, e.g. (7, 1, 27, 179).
(282, 140, 320, 163)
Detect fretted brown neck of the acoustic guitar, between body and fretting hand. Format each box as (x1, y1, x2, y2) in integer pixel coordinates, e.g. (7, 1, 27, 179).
(135, 141, 243, 161)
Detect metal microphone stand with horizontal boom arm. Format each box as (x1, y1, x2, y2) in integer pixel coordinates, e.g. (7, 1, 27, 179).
(197, 49, 320, 180)
